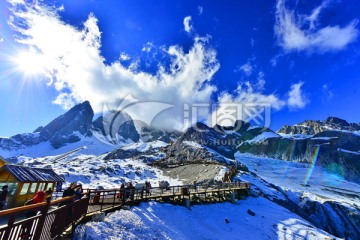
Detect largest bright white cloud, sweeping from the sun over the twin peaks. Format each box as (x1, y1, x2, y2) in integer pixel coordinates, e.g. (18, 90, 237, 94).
(9, 1, 220, 129)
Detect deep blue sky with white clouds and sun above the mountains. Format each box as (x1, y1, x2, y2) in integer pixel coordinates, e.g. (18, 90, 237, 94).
(0, 0, 360, 136)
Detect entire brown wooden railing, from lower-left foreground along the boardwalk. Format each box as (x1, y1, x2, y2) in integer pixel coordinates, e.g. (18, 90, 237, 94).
(0, 182, 250, 240)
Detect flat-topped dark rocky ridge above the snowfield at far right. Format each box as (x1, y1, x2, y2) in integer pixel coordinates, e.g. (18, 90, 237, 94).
(238, 117, 360, 182)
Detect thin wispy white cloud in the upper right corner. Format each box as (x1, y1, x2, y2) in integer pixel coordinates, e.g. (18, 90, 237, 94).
(274, 0, 358, 53)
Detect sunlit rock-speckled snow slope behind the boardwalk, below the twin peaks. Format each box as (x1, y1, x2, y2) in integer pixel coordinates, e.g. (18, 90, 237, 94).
(23, 150, 182, 189)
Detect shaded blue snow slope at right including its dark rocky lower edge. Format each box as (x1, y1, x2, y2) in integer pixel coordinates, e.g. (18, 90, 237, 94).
(236, 153, 360, 239)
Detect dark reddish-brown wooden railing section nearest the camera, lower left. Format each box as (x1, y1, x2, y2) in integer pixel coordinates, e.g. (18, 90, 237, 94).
(0, 197, 89, 240)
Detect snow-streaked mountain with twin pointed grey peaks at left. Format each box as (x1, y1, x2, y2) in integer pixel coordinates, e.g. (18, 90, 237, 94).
(0, 101, 180, 159)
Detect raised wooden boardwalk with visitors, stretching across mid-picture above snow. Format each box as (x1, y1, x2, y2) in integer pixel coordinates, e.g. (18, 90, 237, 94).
(87, 182, 250, 213)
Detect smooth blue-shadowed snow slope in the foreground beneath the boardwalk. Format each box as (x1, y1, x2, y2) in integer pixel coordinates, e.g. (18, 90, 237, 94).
(75, 198, 337, 240)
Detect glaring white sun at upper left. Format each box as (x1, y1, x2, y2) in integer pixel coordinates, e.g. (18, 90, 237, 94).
(13, 49, 45, 76)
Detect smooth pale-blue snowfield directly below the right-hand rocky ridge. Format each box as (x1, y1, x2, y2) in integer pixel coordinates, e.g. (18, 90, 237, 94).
(235, 153, 360, 204)
